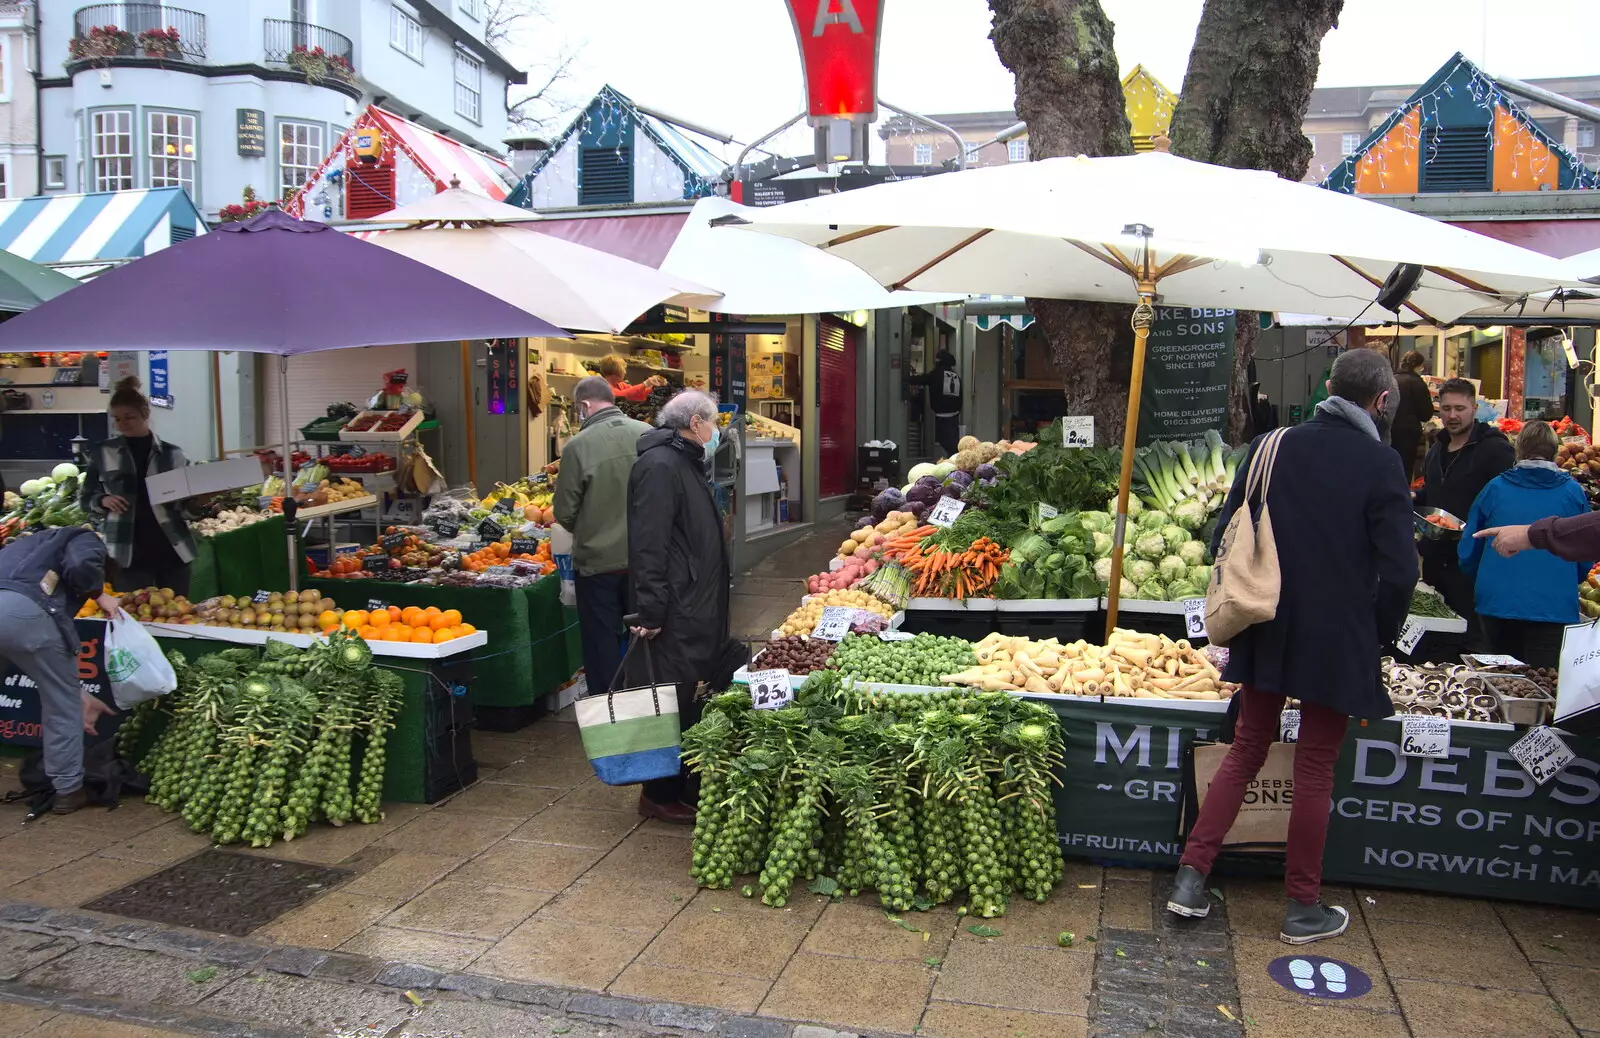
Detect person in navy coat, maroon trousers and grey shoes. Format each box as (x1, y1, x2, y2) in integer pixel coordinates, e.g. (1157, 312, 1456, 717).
(1166, 350, 1418, 944)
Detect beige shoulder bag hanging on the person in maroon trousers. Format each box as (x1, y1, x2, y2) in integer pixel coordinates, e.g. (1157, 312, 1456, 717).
(1205, 429, 1288, 646)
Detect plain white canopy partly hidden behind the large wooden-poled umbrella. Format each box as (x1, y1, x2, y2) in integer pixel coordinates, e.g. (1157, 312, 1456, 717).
(661, 198, 965, 313)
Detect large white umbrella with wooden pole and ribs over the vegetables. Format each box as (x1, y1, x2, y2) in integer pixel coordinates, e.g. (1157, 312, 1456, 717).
(722, 150, 1578, 630)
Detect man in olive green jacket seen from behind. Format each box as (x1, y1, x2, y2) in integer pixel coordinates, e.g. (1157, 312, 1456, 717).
(555, 377, 650, 693)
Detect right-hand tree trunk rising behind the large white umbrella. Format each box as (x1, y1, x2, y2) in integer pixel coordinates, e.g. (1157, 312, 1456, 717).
(1171, 0, 1344, 443)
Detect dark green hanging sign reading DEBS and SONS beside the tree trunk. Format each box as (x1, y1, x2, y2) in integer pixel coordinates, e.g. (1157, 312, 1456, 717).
(1139, 307, 1235, 446)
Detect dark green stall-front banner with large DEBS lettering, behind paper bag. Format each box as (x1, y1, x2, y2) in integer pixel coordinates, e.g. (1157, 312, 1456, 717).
(1050, 701, 1600, 908)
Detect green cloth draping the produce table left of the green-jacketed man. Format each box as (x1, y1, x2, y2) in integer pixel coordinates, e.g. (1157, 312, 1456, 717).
(306, 574, 582, 729)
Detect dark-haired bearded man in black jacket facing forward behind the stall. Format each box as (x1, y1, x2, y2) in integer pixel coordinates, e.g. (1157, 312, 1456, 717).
(1416, 379, 1517, 626)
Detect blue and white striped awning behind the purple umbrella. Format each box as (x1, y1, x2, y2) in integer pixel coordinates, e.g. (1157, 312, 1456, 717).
(0, 187, 206, 265)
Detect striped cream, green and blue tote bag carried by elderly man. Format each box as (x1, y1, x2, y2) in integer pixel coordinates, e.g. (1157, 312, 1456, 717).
(573, 635, 680, 785)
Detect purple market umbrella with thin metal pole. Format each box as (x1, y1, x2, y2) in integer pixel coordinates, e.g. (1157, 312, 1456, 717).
(0, 210, 566, 585)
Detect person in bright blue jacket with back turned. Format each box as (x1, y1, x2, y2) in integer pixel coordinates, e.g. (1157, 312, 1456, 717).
(1459, 422, 1590, 667)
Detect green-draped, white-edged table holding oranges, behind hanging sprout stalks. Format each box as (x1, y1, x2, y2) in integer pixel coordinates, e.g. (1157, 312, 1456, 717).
(150, 621, 488, 803)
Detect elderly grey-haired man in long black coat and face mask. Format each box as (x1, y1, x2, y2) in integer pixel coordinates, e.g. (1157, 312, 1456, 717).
(627, 383, 730, 825)
